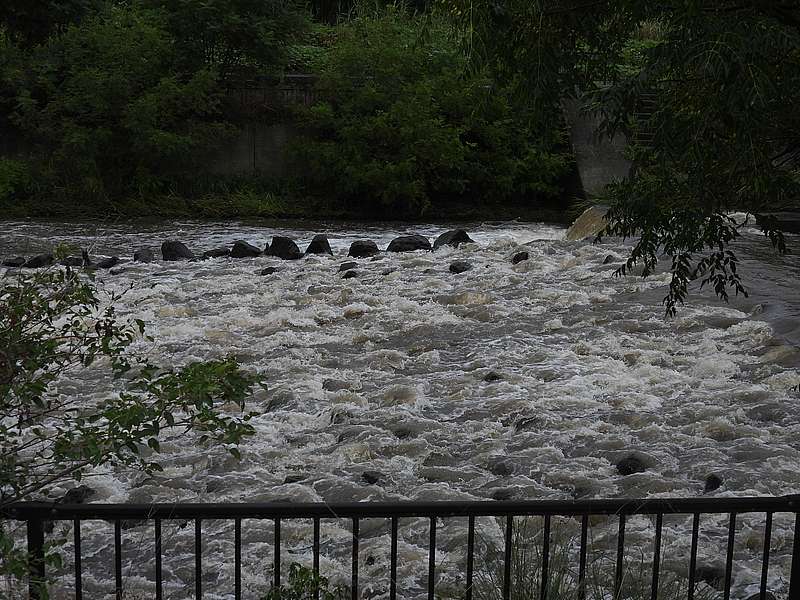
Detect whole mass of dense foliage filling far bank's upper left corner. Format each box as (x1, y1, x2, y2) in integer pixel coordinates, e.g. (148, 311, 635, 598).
(0, 0, 306, 212)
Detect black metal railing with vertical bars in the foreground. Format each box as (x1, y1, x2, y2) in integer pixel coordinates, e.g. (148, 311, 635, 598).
(0, 495, 800, 600)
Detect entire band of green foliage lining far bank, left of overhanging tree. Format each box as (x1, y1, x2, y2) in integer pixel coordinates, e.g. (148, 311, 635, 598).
(0, 0, 569, 217)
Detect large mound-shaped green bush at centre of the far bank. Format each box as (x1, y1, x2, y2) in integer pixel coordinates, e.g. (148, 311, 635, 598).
(293, 8, 569, 217)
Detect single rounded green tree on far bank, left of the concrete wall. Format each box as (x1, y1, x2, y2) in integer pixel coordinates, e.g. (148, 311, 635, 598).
(5, 6, 232, 202)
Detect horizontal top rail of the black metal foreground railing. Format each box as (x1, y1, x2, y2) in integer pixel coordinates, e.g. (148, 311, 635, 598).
(0, 494, 800, 520)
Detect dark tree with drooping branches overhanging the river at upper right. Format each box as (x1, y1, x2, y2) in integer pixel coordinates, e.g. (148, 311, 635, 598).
(440, 0, 800, 313)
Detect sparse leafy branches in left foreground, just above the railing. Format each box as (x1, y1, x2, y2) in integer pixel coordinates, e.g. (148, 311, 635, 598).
(0, 269, 260, 596)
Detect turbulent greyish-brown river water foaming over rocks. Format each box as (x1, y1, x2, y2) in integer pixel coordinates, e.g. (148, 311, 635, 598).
(0, 222, 800, 598)
